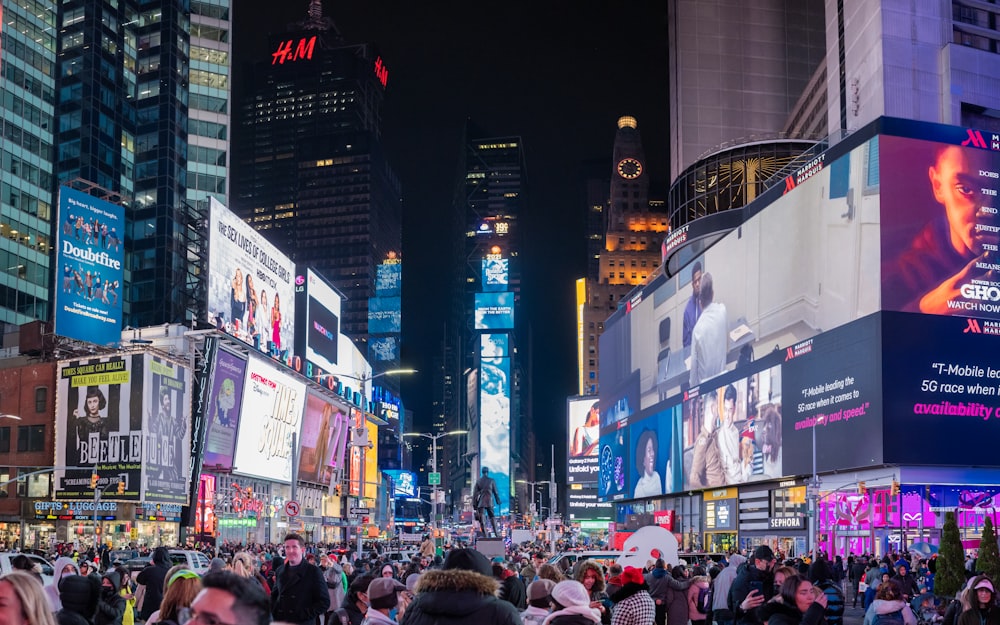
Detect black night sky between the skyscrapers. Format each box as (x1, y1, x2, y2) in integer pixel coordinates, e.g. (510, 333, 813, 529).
(233, 0, 668, 473)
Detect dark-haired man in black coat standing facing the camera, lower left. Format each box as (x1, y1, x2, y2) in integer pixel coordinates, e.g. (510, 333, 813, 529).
(271, 534, 330, 625)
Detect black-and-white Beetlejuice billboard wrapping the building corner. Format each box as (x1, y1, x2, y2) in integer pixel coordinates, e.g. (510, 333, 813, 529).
(55, 354, 192, 504)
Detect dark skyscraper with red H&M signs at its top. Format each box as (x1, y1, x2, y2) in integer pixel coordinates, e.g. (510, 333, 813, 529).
(232, 0, 402, 376)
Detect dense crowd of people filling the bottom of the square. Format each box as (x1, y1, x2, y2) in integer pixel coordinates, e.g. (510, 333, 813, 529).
(7, 533, 1000, 625)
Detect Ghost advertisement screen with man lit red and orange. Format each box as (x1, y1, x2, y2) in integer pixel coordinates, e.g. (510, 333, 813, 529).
(879, 136, 1000, 319)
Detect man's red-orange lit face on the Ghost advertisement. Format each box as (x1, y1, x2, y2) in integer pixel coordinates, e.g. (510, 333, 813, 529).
(928, 146, 982, 254)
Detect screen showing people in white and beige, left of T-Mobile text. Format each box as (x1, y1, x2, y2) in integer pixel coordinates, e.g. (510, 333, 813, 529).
(678, 366, 787, 490)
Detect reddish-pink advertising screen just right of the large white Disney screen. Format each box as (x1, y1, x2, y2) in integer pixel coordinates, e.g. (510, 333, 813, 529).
(299, 393, 350, 484)
